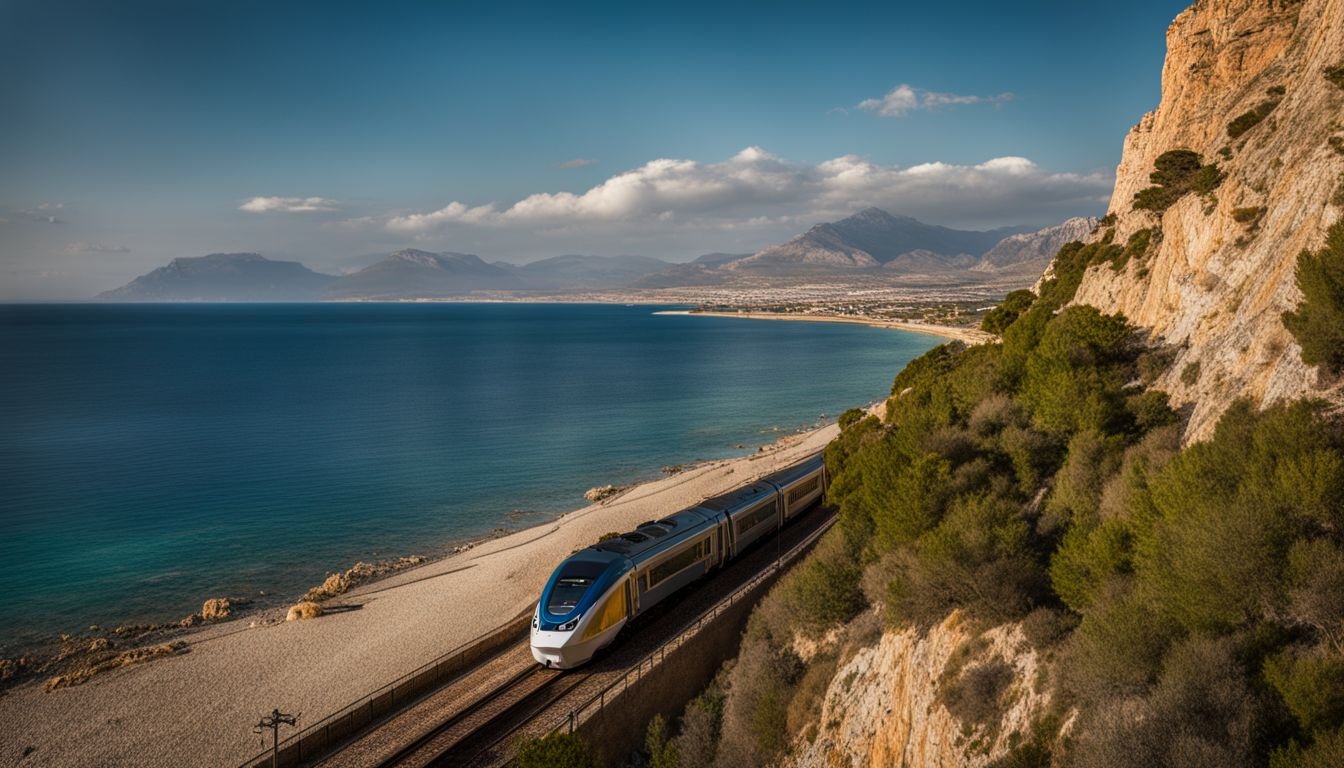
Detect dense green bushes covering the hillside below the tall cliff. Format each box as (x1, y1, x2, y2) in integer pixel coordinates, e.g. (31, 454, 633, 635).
(639, 225, 1344, 768)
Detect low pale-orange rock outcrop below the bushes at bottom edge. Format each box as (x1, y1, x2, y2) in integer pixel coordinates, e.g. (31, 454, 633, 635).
(784, 613, 1048, 768)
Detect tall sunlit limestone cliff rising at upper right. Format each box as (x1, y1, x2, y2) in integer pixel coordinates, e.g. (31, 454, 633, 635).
(1074, 0, 1344, 440)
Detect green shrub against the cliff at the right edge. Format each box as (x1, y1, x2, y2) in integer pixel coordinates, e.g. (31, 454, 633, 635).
(1284, 222, 1344, 375)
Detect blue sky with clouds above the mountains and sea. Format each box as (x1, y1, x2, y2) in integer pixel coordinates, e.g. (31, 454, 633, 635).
(0, 0, 1185, 301)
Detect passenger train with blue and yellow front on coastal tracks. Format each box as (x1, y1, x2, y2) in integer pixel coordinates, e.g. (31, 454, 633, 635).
(531, 453, 828, 670)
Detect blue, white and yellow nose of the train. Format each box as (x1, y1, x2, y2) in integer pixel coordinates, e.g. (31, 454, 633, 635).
(532, 549, 633, 670)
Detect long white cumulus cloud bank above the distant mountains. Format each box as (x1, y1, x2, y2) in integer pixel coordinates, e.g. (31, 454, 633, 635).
(383, 147, 1111, 234)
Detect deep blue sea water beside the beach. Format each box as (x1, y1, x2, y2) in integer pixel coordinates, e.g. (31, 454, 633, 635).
(0, 304, 935, 647)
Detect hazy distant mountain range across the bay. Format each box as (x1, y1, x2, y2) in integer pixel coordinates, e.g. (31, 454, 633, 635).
(98, 208, 1095, 301)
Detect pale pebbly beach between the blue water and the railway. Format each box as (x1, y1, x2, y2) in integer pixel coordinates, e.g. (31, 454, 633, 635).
(0, 424, 860, 765)
